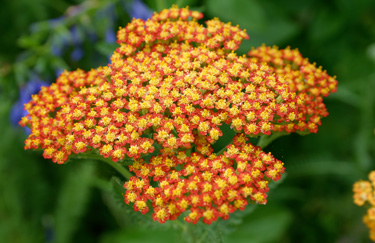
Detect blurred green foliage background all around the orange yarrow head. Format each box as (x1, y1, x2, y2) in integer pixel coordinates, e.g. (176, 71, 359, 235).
(0, 0, 375, 243)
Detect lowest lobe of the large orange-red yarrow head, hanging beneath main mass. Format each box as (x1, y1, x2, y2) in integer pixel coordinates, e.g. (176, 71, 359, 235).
(125, 134, 284, 224)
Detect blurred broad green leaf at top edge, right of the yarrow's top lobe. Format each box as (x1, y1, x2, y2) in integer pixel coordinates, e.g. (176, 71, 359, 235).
(207, 0, 299, 54)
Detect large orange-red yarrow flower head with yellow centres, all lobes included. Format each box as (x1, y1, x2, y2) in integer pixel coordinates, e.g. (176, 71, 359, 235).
(20, 7, 336, 224)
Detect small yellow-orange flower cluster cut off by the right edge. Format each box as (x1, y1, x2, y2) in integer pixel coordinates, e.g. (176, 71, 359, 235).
(353, 171, 375, 241)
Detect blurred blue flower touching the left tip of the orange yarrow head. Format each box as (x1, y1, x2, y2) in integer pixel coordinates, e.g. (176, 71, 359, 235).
(10, 77, 49, 134)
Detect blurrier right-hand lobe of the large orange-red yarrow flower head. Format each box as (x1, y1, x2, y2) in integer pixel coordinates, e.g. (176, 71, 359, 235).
(248, 45, 337, 133)
